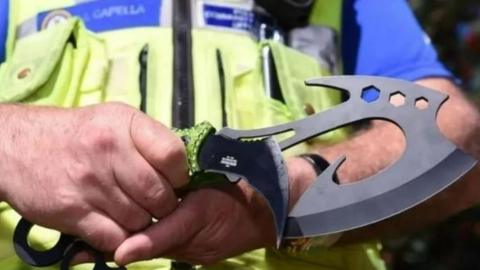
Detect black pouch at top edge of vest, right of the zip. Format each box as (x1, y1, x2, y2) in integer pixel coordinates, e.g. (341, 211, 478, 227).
(255, 0, 315, 30)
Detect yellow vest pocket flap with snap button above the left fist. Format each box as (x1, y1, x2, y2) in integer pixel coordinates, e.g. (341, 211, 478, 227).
(0, 19, 106, 107)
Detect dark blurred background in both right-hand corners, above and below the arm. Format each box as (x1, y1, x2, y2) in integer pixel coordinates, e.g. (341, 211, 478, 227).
(383, 0, 480, 270)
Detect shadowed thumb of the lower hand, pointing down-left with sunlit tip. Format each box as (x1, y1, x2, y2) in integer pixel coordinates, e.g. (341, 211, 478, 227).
(115, 200, 203, 265)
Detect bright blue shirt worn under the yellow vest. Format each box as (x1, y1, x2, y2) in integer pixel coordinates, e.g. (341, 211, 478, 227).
(0, 0, 451, 80)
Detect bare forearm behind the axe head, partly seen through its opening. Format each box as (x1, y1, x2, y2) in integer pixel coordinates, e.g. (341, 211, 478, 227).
(290, 79, 480, 242)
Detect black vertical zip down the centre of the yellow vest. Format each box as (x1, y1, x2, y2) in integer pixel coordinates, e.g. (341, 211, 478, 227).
(172, 0, 195, 128)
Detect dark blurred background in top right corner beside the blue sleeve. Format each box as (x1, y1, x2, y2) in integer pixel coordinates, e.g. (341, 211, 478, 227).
(410, 0, 480, 97)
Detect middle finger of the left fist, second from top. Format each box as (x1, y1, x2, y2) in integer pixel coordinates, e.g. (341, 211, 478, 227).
(115, 152, 178, 219)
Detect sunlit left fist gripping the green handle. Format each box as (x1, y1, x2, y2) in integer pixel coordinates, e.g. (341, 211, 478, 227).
(0, 104, 188, 252)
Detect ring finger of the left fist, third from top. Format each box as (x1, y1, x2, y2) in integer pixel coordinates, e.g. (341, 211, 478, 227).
(88, 182, 152, 232)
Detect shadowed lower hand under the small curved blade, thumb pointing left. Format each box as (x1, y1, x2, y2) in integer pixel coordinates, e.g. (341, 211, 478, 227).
(115, 158, 315, 265)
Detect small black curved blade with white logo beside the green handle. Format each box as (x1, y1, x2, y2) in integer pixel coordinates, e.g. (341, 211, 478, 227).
(198, 135, 288, 245)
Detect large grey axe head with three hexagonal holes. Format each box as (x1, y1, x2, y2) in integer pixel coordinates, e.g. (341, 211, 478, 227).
(222, 76, 476, 238)
